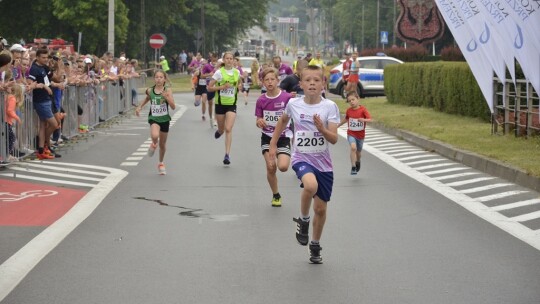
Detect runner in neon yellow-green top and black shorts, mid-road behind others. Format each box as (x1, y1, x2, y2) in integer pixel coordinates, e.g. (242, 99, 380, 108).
(208, 52, 242, 165)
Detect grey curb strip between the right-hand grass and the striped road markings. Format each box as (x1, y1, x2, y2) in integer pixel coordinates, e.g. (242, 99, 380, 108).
(371, 122, 540, 191)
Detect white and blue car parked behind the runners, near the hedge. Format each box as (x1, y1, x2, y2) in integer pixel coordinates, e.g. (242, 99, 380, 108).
(328, 56, 403, 98)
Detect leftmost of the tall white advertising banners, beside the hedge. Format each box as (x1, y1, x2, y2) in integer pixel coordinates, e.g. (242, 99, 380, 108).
(435, 0, 493, 113)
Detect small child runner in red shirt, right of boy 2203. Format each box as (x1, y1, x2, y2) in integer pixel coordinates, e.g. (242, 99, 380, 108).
(339, 91, 371, 175)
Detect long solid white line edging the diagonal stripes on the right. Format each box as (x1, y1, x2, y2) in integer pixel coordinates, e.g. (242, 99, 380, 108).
(354, 130, 540, 250)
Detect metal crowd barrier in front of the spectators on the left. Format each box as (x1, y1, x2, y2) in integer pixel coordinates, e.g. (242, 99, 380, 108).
(0, 74, 146, 165)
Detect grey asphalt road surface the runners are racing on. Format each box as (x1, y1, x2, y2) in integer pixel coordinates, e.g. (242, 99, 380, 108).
(0, 92, 540, 304)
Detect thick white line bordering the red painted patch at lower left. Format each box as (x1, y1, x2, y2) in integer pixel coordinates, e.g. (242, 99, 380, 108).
(0, 164, 128, 302)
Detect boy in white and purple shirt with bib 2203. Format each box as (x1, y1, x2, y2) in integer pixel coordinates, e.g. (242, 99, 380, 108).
(269, 66, 340, 264)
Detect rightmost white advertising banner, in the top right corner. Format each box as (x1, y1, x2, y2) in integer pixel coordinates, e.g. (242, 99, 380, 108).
(474, 0, 540, 93)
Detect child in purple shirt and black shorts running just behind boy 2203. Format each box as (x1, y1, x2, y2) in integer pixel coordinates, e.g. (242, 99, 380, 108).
(255, 68, 292, 207)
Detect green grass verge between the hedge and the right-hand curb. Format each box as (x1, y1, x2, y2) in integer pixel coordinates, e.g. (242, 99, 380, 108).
(171, 75, 540, 177)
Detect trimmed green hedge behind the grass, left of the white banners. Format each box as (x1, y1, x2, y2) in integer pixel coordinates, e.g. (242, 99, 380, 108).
(384, 62, 490, 121)
